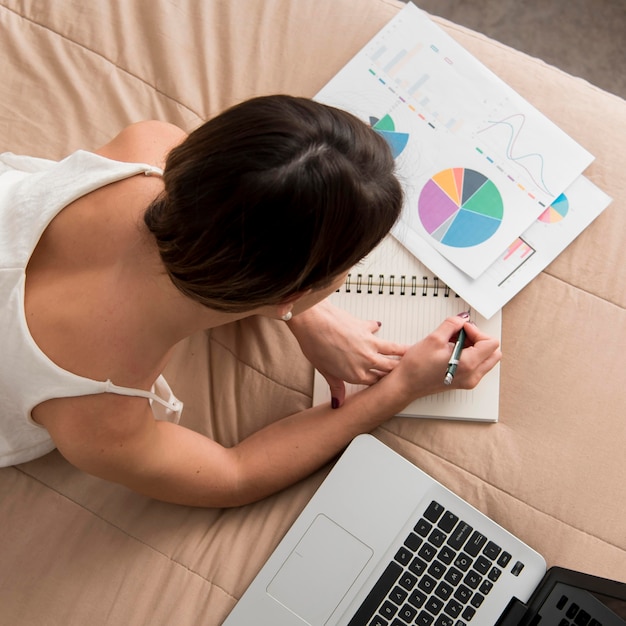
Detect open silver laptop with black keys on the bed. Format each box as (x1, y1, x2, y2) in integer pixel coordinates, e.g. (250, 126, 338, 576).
(224, 435, 626, 626)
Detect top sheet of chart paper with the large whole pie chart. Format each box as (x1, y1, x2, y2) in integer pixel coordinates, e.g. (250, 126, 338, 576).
(316, 4, 593, 280)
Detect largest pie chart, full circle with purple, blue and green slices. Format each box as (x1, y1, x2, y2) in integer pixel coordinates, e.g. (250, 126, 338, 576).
(417, 167, 504, 248)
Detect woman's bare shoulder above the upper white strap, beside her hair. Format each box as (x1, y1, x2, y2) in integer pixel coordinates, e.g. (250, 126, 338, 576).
(95, 120, 187, 167)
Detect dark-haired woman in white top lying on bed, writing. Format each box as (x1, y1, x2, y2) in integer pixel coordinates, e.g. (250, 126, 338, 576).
(0, 96, 500, 506)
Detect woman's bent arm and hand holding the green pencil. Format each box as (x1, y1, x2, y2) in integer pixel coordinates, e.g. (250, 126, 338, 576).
(37, 318, 500, 507)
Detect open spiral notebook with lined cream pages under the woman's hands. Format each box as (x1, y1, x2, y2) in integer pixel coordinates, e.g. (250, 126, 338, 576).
(313, 236, 502, 422)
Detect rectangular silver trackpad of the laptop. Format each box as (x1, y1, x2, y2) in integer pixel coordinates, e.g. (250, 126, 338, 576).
(267, 515, 373, 626)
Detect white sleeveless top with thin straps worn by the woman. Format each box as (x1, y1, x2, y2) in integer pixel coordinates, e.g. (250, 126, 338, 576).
(0, 151, 182, 467)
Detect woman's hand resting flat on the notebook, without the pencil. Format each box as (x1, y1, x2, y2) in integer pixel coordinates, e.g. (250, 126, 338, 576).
(289, 300, 408, 408)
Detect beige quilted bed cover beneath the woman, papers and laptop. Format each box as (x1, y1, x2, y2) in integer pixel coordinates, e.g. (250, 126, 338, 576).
(0, 0, 626, 626)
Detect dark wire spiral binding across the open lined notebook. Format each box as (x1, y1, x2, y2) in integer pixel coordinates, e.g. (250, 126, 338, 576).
(337, 273, 459, 298)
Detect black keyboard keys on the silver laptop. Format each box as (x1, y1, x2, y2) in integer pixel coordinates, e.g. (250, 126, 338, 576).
(349, 500, 524, 626)
